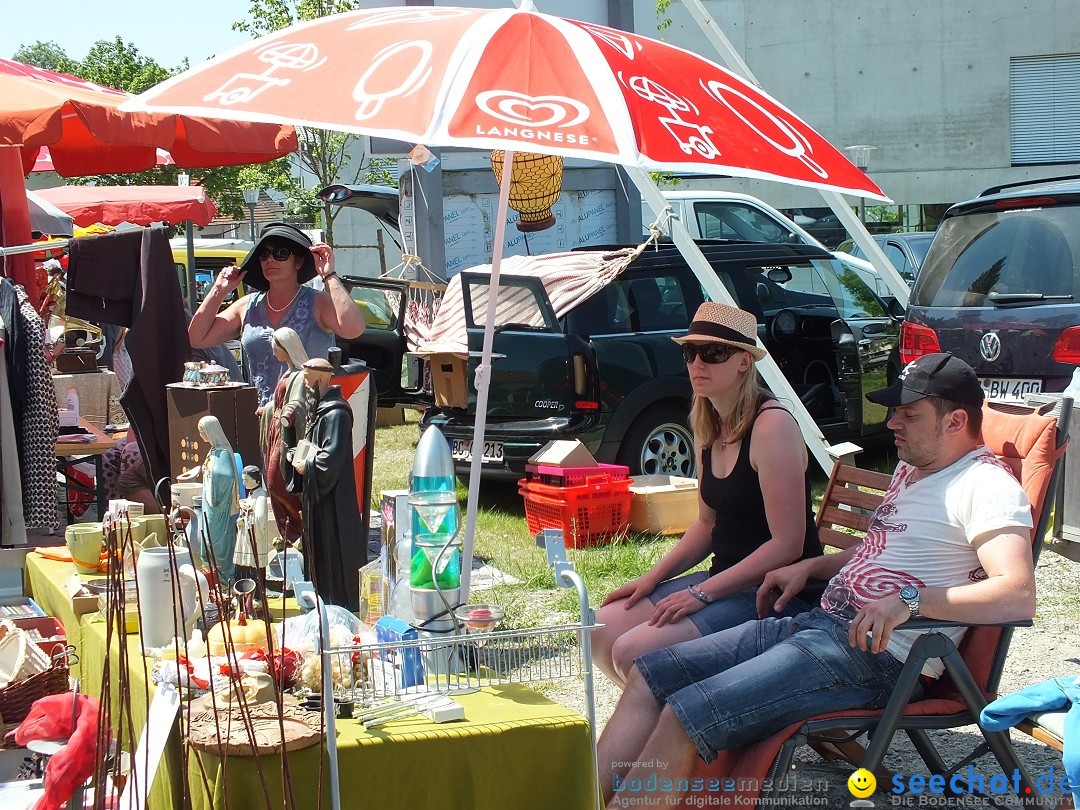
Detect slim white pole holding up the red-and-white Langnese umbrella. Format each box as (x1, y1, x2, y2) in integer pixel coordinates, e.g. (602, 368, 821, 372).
(461, 149, 514, 602)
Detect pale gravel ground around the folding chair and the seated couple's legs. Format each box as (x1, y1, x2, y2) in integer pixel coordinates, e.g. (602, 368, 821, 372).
(535, 551, 1080, 808)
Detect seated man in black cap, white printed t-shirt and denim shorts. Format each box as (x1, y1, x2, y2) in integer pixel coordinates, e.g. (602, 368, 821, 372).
(597, 353, 1035, 807)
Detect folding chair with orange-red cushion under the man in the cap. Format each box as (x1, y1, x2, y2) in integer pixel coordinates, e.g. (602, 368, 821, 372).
(759, 399, 1071, 807)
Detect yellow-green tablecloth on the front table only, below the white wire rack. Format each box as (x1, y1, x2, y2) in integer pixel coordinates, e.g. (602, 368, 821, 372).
(188, 685, 594, 810)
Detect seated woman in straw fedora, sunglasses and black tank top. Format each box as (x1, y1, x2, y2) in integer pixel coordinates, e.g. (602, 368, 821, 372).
(593, 301, 822, 686)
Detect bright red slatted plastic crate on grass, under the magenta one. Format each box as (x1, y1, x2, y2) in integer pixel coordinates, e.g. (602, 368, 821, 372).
(517, 478, 630, 549)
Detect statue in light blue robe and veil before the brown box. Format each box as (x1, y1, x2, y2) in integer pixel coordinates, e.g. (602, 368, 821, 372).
(199, 416, 240, 584)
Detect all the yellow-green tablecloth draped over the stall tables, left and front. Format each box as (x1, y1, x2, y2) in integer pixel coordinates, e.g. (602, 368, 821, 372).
(27, 554, 595, 810)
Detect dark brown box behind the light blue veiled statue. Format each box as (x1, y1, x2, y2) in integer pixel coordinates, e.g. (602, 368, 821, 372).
(165, 383, 262, 478)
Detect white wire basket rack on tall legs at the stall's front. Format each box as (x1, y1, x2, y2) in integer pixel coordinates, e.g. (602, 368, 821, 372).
(318, 529, 599, 810)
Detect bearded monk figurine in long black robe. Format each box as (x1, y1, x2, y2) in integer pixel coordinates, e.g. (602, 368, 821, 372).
(291, 359, 367, 612)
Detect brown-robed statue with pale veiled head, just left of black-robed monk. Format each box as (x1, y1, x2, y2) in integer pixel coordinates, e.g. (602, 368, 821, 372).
(259, 326, 308, 543)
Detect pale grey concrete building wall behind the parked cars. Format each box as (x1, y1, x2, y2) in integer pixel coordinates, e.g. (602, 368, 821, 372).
(633, 0, 1080, 207)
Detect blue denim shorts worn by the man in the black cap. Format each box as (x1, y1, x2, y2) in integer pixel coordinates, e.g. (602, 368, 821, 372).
(635, 608, 903, 762)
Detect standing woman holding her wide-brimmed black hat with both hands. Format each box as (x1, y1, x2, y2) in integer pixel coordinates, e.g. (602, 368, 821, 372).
(188, 222, 364, 406)
